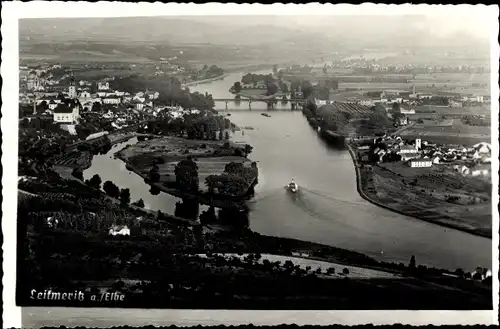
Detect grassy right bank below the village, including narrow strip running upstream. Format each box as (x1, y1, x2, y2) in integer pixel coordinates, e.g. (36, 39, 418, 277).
(346, 140, 492, 239)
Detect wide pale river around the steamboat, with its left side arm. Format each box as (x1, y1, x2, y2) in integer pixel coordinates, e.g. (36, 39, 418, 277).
(84, 72, 492, 271)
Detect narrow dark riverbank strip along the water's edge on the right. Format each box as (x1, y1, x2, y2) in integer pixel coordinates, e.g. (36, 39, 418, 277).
(345, 139, 492, 239)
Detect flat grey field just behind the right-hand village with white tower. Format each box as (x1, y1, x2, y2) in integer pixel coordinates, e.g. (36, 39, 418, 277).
(400, 119, 491, 146)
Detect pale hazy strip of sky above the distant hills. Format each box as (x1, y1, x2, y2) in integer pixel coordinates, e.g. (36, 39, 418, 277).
(19, 14, 491, 39)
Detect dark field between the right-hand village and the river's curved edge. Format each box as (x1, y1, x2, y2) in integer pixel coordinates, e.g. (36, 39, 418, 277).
(362, 163, 492, 236)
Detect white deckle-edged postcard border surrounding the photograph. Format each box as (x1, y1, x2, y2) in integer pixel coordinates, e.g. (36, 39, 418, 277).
(1, 1, 499, 328)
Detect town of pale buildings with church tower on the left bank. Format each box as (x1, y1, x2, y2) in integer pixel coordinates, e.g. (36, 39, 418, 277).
(19, 65, 196, 134)
